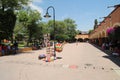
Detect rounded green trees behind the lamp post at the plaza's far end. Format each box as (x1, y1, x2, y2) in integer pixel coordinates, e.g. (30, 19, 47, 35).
(47, 18, 77, 41)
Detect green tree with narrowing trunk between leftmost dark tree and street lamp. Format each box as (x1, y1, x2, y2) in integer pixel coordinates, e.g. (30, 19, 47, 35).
(18, 8, 42, 46)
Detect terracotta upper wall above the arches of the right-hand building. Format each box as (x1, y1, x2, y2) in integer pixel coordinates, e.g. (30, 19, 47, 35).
(89, 6, 120, 38)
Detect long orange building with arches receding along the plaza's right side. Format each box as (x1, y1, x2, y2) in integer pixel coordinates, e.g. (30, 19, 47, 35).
(89, 4, 120, 46)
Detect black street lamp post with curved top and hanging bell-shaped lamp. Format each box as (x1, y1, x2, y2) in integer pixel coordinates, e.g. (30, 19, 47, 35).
(44, 6, 56, 59)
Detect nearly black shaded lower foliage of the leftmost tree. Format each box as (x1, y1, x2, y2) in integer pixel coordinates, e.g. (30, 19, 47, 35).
(0, 10, 16, 40)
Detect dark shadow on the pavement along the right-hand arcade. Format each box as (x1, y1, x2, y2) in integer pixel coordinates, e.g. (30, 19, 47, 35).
(91, 44, 120, 67)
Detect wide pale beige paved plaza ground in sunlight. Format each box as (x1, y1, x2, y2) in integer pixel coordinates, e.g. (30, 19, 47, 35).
(0, 43, 120, 80)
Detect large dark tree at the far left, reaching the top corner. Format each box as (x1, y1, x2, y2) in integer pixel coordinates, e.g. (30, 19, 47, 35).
(0, 0, 29, 41)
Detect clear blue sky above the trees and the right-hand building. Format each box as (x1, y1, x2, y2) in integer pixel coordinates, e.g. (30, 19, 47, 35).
(30, 0, 120, 31)
